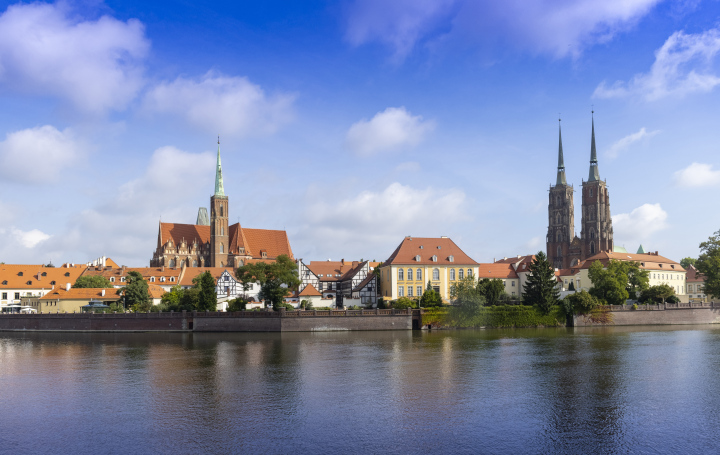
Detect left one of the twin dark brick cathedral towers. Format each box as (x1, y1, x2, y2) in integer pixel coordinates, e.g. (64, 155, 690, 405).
(547, 120, 575, 269)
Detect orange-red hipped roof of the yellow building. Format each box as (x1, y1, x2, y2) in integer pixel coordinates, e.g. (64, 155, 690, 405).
(382, 237, 477, 267)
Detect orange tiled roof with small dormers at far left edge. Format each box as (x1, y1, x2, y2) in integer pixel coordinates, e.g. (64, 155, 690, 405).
(0, 264, 85, 289)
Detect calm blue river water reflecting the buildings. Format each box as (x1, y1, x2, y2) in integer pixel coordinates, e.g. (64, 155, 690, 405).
(0, 327, 720, 454)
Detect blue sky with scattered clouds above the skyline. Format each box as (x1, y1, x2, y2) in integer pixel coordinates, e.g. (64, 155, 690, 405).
(0, 0, 720, 266)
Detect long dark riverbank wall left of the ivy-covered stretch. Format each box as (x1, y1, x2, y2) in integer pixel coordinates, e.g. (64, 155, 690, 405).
(0, 310, 413, 332)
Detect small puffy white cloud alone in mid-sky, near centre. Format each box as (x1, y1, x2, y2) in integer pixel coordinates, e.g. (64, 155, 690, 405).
(346, 107, 435, 156)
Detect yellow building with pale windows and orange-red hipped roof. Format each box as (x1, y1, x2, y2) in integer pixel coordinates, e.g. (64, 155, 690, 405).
(380, 236, 478, 302)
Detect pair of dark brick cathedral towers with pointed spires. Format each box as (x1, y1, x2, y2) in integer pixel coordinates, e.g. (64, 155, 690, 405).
(547, 114, 613, 269)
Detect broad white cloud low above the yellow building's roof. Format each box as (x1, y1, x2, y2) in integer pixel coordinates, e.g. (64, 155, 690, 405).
(293, 182, 467, 259)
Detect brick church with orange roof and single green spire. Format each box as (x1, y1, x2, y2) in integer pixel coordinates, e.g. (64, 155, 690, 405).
(150, 140, 293, 268)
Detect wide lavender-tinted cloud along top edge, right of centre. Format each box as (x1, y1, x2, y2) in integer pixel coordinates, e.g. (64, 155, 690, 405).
(346, 0, 660, 58)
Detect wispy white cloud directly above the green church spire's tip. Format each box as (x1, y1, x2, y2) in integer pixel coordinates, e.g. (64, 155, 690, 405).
(145, 71, 295, 135)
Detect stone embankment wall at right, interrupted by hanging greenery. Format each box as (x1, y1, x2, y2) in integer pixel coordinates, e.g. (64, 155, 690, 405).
(575, 302, 720, 327)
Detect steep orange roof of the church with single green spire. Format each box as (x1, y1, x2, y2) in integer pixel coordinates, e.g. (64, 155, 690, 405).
(158, 222, 293, 259)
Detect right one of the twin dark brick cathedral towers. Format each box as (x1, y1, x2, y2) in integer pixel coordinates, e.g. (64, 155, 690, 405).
(580, 112, 614, 259)
